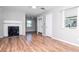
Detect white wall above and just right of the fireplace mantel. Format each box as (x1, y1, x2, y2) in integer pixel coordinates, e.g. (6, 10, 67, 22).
(3, 9, 25, 35)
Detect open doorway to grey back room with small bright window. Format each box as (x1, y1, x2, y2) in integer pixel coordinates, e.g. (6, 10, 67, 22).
(25, 16, 37, 33)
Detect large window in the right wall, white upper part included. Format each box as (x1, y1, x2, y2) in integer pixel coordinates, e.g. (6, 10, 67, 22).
(64, 8, 77, 29)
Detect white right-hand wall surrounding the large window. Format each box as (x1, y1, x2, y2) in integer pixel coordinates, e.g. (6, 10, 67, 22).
(52, 7, 79, 44)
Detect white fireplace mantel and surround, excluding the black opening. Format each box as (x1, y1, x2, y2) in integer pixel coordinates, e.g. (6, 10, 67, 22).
(3, 20, 22, 36)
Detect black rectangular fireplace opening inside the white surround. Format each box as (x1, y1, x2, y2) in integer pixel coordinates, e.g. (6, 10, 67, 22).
(8, 26, 19, 37)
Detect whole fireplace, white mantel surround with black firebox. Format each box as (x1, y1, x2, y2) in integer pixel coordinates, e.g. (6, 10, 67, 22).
(3, 20, 23, 37)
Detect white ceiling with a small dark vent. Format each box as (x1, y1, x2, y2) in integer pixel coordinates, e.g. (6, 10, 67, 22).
(2, 6, 56, 16)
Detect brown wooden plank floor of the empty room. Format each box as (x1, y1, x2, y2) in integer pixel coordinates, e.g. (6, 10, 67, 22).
(0, 34, 79, 52)
